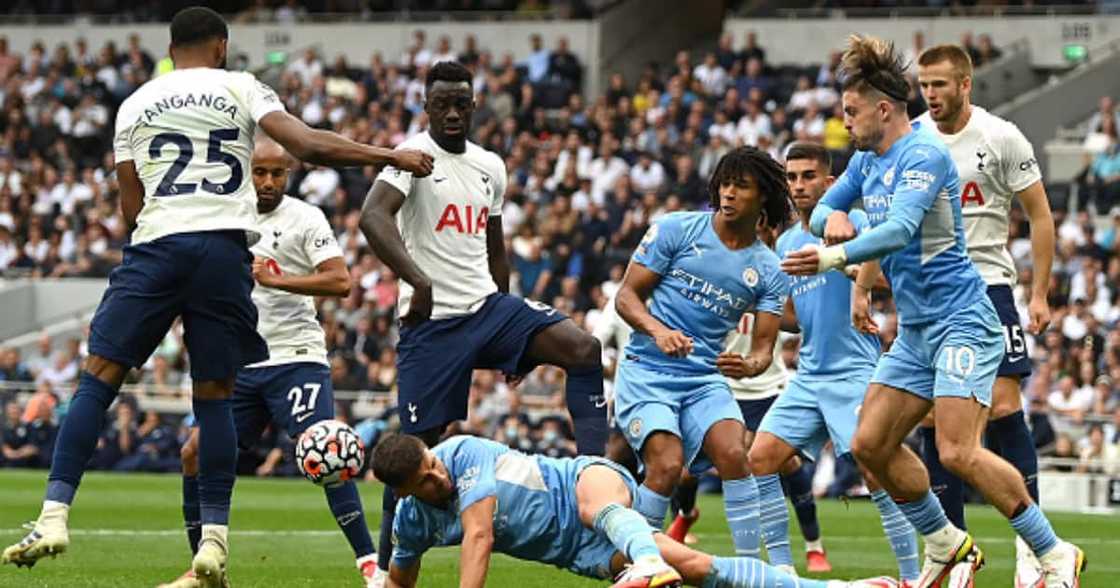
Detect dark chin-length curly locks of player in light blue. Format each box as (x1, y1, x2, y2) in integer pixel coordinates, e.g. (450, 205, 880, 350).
(708, 147, 793, 228)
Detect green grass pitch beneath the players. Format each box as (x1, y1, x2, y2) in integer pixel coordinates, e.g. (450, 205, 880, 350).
(0, 470, 1120, 588)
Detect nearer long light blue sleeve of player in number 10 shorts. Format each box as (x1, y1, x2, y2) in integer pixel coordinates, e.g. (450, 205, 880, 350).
(843, 146, 953, 263)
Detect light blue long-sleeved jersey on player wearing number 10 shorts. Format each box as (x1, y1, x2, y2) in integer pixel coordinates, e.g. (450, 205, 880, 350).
(810, 125, 986, 325)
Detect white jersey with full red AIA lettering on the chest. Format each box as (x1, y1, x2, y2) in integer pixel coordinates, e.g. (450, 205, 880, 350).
(377, 131, 506, 319)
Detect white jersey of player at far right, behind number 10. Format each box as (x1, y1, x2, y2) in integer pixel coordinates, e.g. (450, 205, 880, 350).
(918, 105, 1042, 286)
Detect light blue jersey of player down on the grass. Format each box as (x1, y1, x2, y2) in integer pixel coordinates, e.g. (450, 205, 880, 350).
(393, 436, 595, 568)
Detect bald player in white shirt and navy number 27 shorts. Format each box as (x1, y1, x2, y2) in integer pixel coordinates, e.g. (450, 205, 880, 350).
(167, 139, 377, 588)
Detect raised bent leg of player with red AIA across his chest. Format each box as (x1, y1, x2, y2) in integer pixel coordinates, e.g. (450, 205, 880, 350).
(495, 296, 610, 456)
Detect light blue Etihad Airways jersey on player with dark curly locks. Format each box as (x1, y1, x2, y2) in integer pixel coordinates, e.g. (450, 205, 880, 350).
(625, 212, 787, 374)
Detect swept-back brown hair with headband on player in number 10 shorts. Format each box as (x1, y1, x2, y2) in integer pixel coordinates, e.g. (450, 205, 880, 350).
(840, 35, 911, 104)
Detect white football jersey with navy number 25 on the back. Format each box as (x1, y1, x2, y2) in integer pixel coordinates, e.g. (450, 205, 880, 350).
(113, 67, 283, 244)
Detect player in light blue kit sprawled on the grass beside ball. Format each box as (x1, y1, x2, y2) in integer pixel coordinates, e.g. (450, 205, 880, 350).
(373, 435, 896, 588)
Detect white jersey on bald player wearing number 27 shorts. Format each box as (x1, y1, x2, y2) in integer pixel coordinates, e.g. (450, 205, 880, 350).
(250, 196, 343, 367)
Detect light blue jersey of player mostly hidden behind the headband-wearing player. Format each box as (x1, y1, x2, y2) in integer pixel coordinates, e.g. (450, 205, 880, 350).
(774, 211, 879, 375)
